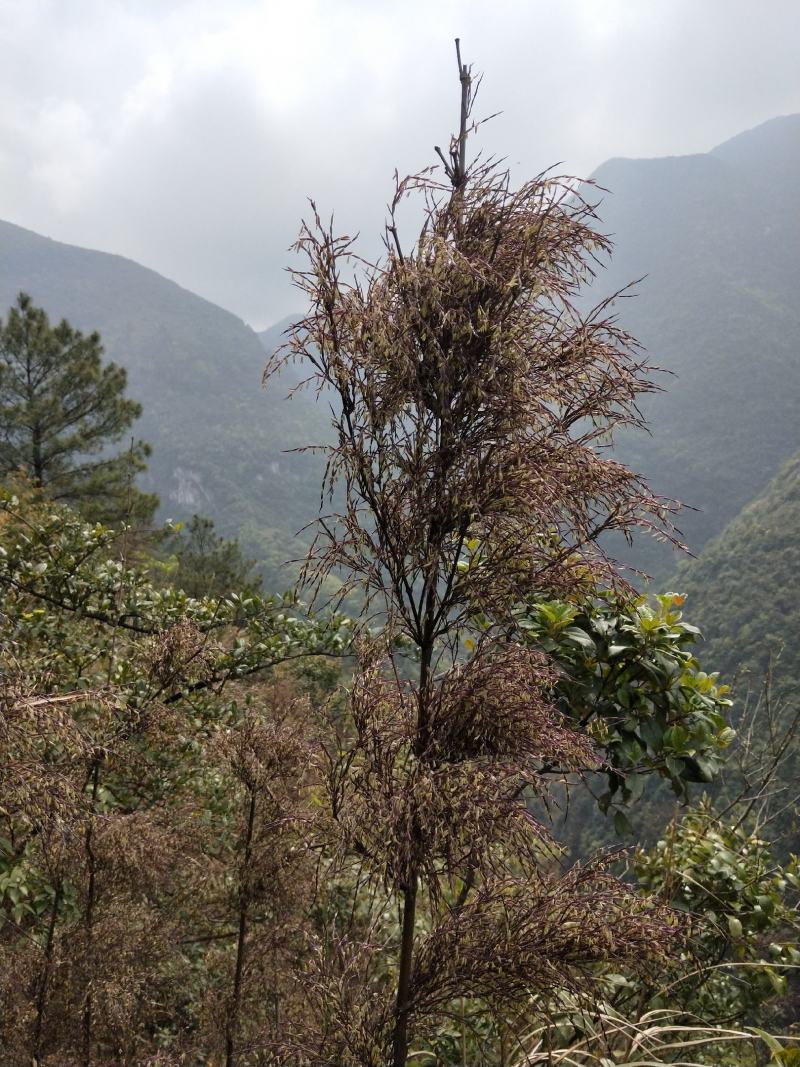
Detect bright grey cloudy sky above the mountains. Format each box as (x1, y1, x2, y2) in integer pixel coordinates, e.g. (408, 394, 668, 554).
(0, 0, 800, 328)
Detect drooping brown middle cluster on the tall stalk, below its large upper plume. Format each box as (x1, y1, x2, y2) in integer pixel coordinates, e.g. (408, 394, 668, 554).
(327, 646, 596, 899)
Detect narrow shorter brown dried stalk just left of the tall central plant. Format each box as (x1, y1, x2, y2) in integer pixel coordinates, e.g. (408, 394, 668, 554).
(201, 682, 314, 1065)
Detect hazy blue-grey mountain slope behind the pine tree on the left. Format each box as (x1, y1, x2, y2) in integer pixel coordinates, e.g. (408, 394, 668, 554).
(0, 223, 324, 582)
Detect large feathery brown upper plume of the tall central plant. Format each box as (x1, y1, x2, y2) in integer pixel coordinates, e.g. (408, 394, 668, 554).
(268, 137, 671, 643)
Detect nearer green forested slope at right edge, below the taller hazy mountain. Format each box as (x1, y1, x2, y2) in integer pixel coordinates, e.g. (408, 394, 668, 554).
(674, 451, 800, 694)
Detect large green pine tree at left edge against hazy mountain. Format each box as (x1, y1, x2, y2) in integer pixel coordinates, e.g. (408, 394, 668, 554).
(0, 292, 158, 522)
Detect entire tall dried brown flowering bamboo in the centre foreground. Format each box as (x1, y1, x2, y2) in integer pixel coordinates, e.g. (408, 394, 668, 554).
(267, 41, 691, 1067)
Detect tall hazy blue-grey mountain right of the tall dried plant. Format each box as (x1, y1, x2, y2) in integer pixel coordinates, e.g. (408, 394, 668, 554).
(594, 115, 800, 578)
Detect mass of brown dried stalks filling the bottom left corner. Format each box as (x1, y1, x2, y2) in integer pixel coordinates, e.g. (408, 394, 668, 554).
(0, 657, 322, 1067)
